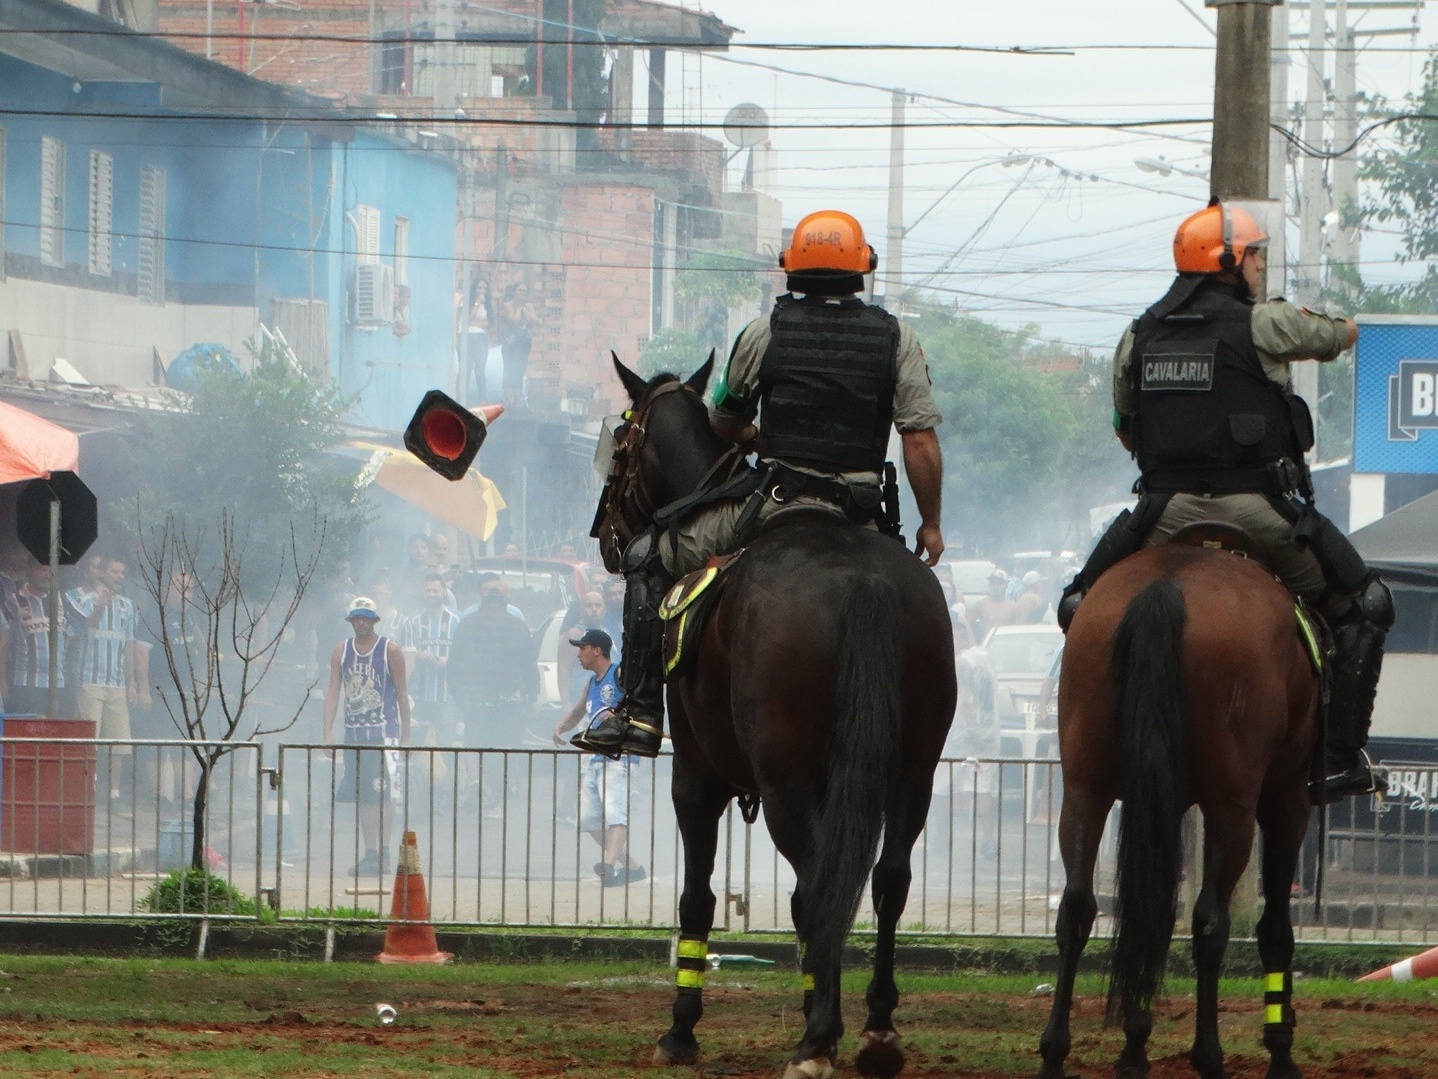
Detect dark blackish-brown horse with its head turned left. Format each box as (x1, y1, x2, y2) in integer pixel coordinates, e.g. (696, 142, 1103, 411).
(595, 355, 956, 1079)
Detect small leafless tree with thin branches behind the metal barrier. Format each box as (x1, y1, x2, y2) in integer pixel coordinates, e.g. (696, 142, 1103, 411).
(138, 511, 325, 869)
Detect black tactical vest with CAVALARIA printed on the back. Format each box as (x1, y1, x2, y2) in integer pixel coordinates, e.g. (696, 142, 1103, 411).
(1129, 275, 1313, 491)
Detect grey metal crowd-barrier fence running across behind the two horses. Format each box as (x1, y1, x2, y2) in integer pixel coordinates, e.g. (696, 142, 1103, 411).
(0, 738, 1438, 944)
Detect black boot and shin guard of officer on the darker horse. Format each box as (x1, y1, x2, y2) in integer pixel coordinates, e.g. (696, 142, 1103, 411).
(569, 532, 674, 760)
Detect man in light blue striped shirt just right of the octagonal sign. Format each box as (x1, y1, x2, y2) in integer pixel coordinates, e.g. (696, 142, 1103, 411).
(66, 558, 138, 800)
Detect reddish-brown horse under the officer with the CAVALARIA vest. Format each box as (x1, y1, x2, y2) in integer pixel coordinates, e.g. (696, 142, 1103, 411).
(1038, 545, 1320, 1079)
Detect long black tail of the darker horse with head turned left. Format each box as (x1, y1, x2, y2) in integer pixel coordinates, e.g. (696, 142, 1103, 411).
(802, 575, 903, 970)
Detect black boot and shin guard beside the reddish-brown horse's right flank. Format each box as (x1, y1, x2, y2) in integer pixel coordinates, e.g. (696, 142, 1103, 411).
(1309, 577, 1393, 806)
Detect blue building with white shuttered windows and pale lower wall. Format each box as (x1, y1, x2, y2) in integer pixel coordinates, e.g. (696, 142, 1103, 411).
(0, 0, 457, 429)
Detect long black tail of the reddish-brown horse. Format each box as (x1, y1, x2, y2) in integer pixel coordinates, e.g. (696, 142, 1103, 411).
(1106, 581, 1188, 1023)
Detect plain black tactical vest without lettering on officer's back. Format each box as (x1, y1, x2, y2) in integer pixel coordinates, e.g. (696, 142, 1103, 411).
(759, 296, 899, 472)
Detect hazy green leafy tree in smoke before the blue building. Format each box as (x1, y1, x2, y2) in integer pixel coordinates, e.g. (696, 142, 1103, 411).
(108, 345, 365, 584)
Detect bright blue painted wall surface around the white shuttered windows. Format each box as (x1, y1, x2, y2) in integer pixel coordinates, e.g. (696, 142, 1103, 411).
(0, 55, 457, 429)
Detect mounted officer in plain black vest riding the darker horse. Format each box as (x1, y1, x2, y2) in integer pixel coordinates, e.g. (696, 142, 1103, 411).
(571, 210, 943, 757)
